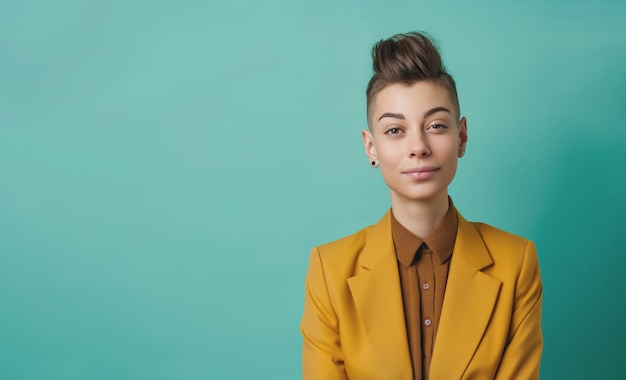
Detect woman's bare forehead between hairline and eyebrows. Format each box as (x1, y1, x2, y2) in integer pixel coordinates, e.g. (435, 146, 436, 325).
(372, 81, 454, 120)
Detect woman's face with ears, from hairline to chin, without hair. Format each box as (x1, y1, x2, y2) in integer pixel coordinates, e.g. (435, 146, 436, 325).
(363, 81, 467, 201)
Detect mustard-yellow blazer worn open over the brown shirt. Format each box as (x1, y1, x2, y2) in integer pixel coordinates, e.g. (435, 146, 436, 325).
(301, 211, 543, 380)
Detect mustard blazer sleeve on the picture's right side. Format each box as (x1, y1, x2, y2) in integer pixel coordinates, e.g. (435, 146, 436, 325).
(496, 241, 543, 380)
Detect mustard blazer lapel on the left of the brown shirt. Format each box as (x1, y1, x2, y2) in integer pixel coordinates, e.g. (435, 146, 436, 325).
(348, 212, 413, 380)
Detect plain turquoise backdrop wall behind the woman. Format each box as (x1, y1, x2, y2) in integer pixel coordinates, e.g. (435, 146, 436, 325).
(0, 0, 626, 379)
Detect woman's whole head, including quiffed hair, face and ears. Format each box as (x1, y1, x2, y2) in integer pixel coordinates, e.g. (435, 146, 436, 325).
(362, 33, 467, 204)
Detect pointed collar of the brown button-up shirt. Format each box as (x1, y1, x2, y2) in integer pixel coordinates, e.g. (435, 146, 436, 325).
(391, 198, 458, 267)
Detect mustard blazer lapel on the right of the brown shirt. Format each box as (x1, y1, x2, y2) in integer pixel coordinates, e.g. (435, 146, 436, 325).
(430, 214, 501, 379)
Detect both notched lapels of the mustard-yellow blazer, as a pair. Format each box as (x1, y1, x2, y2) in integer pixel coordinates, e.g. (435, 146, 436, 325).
(348, 211, 501, 379)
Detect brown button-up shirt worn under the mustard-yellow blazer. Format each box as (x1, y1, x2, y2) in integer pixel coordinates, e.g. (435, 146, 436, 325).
(391, 200, 458, 380)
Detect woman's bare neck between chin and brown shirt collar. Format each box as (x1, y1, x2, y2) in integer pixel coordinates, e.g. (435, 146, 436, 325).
(391, 191, 449, 240)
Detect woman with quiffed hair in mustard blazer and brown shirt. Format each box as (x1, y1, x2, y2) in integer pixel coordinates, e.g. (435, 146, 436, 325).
(301, 32, 543, 380)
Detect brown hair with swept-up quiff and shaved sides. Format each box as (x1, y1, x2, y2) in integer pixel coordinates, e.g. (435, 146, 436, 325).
(366, 32, 461, 124)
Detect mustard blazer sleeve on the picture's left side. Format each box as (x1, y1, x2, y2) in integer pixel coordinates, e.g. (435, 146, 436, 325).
(300, 248, 348, 380)
